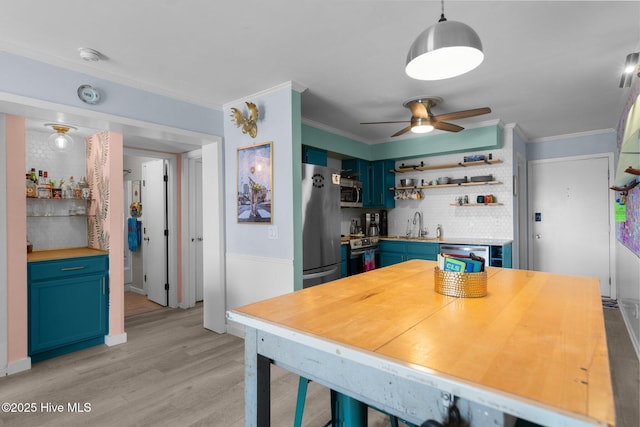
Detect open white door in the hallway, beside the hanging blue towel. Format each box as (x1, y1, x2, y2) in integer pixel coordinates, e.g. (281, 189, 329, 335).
(140, 160, 168, 306)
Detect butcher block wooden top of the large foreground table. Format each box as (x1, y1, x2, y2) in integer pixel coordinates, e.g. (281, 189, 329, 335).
(229, 260, 615, 425)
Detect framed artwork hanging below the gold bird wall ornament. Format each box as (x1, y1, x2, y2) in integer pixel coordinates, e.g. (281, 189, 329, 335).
(237, 142, 273, 224)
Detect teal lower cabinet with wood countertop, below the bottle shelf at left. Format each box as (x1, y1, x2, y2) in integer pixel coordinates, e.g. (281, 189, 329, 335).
(27, 255, 109, 362)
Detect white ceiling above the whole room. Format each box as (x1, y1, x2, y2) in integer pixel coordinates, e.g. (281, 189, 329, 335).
(0, 0, 640, 150)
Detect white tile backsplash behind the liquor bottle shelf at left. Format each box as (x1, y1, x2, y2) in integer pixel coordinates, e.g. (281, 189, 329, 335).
(25, 131, 87, 250)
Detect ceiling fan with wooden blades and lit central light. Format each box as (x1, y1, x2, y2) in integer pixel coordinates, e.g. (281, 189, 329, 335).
(360, 96, 491, 137)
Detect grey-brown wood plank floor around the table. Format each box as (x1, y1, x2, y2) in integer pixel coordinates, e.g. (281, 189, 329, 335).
(0, 305, 640, 427)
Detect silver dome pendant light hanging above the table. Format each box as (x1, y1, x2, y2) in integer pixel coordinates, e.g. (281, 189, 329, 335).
(405, 0, 484, 80)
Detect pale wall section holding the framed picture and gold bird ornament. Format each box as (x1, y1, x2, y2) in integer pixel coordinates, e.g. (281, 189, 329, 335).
(224, 86, 297, 332)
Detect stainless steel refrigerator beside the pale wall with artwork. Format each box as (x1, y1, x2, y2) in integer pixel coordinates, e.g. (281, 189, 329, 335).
(302, 163, 340, 288)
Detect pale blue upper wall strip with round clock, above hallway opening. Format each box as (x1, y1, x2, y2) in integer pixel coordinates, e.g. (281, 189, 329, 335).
(0, 52, 224, 136)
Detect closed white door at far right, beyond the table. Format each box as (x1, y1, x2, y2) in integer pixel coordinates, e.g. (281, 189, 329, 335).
(529, 157, 611, 298)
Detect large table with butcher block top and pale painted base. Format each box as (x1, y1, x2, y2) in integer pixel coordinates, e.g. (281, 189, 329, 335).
(227, 260, 615, 426)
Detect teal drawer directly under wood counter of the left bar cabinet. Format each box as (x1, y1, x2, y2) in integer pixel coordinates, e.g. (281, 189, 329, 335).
(28, 255, 109, 281)
